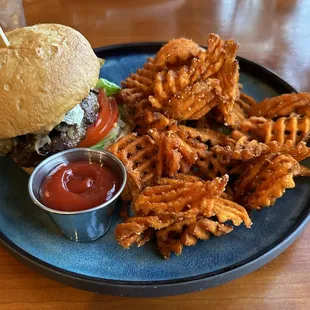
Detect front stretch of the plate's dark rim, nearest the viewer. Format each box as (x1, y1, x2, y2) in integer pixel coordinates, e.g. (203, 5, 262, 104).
(0, 202, 310, 297)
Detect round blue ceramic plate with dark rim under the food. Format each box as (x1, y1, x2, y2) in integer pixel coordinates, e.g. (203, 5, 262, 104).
(0, 43, 310, 296)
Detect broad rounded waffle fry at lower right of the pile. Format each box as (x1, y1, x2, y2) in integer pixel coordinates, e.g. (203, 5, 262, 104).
(234, 154, 300, 209)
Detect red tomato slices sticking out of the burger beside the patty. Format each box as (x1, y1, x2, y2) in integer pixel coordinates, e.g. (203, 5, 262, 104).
(79, 89, 118, 147)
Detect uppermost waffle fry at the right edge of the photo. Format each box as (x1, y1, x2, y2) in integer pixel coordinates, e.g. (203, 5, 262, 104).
(249, 93, 310, 118)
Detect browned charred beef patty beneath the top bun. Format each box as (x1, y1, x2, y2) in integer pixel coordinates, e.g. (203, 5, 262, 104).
(12, 91, 99, 167)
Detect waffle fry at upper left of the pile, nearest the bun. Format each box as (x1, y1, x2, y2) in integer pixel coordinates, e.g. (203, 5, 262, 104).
(119, 58, 156, 105)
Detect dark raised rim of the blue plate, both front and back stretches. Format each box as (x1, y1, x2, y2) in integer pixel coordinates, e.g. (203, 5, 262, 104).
(0, 42, 310, 296)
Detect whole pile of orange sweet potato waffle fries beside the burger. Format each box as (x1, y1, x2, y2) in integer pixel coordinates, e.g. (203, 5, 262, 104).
(109, 34, 310, 258)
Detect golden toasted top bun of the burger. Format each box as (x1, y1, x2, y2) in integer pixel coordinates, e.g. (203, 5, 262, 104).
(0, 24, 100, 139)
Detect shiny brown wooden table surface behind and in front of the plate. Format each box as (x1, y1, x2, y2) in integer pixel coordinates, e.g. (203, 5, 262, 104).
(0, 0, 310, 310)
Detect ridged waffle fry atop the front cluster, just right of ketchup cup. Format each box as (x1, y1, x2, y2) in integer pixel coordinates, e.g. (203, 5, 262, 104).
(131, 176, 228, 216)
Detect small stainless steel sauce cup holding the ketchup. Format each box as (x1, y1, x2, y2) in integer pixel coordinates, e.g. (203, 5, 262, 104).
(28, 148, 126, 242)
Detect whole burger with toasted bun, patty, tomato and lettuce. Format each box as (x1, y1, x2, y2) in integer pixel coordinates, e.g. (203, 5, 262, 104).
(0, 24, 125, 172)
